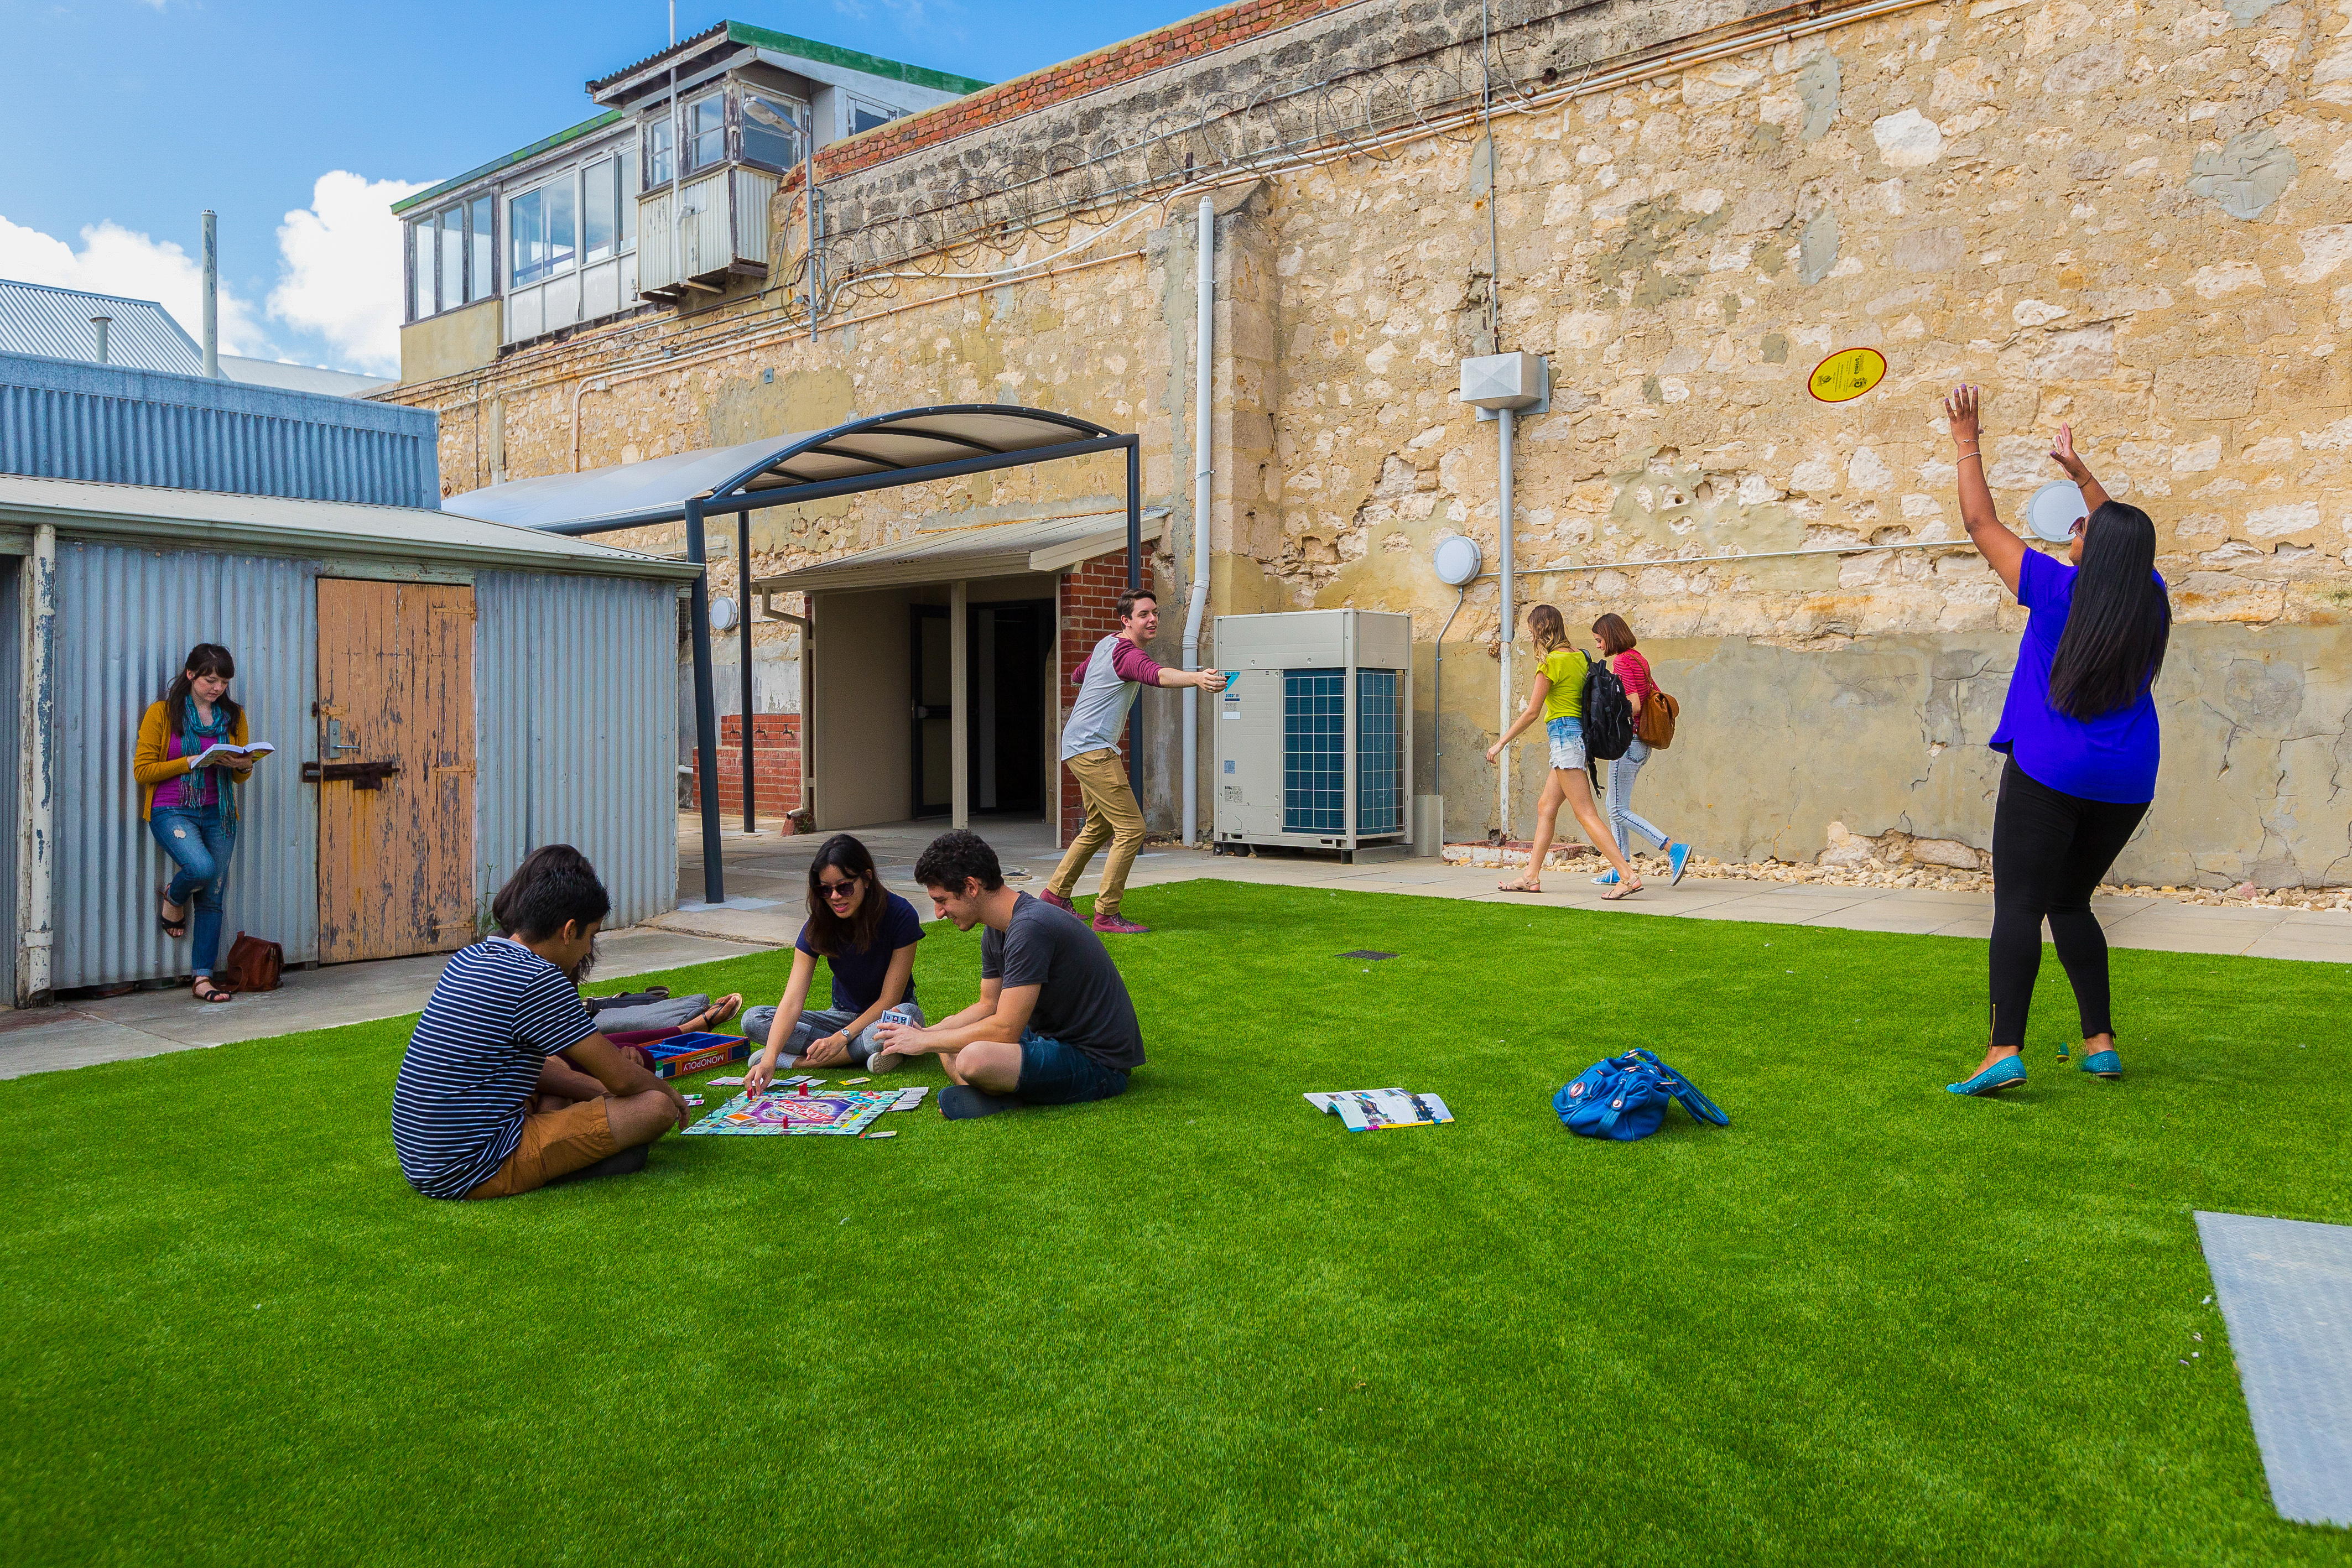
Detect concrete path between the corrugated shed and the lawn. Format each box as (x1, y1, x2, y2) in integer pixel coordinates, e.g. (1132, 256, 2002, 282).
(0, 926, 743, 1079)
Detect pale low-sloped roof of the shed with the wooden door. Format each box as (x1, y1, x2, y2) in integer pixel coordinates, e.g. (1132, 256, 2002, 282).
(0, 475, 701, 581)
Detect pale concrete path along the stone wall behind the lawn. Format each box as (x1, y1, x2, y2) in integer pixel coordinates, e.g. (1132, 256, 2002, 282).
(659, 818, 2352, 964)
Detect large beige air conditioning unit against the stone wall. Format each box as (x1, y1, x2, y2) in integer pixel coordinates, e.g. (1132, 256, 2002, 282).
(1209, 609, 1413, 858)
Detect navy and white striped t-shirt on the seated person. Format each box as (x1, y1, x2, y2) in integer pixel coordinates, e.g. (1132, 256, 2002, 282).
(393, 936, 595, 1199)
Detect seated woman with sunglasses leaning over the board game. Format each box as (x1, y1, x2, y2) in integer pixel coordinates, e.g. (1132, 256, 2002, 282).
(743, 832, 924, 1093)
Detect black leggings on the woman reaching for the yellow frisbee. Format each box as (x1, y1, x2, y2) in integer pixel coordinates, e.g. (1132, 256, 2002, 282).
(1992, 757, 2147, 1049)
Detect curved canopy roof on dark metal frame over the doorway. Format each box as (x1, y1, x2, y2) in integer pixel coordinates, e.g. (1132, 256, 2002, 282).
(442, 402, 1129, 534)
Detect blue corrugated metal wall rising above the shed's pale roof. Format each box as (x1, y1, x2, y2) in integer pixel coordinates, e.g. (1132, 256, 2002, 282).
(0, 353, 440, 508)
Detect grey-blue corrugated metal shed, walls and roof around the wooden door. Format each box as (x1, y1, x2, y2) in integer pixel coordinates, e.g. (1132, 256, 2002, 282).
(0, 475, 696, 989)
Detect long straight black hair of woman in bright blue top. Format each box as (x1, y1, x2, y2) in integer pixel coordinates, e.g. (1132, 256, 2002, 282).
(2051, 501, 2173, 720)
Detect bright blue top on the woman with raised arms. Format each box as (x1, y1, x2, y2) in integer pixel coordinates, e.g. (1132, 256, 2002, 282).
(1992, 550, 2164, 806)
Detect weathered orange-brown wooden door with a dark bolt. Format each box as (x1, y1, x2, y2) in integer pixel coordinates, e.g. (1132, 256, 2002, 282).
(318, 579, 475, 964)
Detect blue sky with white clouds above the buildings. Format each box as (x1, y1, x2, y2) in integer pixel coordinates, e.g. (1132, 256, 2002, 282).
(0, 0, 1204, 374)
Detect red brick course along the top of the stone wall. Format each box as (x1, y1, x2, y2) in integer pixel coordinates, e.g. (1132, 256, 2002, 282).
(816, 0, 1355, 181)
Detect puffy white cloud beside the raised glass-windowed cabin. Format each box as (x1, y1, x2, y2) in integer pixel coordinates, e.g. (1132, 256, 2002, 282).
(270, 169, 426, 376)
